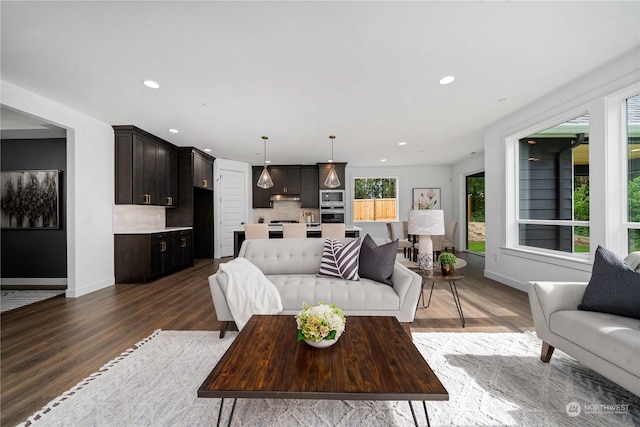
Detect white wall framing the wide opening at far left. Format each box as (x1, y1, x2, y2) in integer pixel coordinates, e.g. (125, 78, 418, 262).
(1, 81, 115, 297)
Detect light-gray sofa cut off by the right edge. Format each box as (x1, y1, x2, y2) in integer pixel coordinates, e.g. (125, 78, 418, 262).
(529, 252, 640, 396)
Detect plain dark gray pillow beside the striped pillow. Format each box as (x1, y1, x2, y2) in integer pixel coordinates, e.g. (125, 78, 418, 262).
(360, 234, 398, 286)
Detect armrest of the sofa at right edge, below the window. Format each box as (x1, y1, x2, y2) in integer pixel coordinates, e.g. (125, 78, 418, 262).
(529, 282, 587, 341)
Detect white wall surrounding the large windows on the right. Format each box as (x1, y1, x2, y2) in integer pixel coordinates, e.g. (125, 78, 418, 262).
(484, 50, 640, 290)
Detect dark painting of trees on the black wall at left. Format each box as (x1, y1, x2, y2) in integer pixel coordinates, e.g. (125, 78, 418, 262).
(0, 170, 60, 230)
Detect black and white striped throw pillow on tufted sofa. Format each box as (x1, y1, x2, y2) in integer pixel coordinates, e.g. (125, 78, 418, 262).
(317, 237, 362, 280)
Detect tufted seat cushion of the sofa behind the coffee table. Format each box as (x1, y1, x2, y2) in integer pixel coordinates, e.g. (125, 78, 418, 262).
(267, 274, 400, 315)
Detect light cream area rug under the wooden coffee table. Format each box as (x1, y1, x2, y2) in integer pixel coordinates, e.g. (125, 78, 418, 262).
(21, 331, 640, 427)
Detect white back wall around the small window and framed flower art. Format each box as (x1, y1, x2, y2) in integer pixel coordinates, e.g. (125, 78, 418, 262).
(345, 164, 455, 237)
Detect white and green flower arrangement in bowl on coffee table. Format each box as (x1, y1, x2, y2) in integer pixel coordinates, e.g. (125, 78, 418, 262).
(296, 301, 347, 342)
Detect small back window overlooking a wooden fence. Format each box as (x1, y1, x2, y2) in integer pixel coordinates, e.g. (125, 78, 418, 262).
(353, 178, 398, 222)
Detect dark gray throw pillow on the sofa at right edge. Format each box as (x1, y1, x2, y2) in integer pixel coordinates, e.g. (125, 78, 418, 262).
(578, 246, 640, 319)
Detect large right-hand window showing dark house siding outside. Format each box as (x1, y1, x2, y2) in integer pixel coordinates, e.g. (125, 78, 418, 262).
(517, 114, 589, 253)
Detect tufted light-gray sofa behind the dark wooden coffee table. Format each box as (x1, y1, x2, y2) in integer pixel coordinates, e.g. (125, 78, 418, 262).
(209, 238, 422, 338)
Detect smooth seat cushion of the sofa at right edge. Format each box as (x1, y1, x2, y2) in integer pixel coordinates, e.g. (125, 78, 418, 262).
(549, 310, 640, 376)
